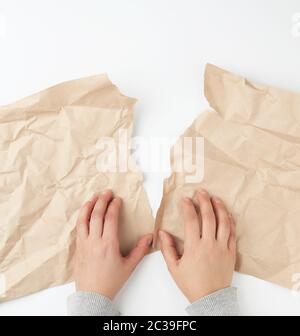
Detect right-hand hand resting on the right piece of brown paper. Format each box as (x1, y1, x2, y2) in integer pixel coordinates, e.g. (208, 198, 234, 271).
(159, 190, 236, 302)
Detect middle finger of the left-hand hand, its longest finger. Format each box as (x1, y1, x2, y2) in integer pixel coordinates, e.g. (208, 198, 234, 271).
(90, 190, 113, 238)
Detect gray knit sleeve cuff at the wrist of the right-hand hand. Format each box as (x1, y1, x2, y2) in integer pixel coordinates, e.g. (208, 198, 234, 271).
(186, 287, 239, 316)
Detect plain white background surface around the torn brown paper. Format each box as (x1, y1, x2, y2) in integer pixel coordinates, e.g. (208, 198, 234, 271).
(0, 0, 300, 315)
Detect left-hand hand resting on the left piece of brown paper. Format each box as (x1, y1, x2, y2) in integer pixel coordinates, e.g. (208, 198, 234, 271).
(74, 190, 152, 299)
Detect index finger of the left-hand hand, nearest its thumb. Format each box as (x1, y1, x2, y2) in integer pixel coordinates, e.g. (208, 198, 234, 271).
(102, 197, 122, 241)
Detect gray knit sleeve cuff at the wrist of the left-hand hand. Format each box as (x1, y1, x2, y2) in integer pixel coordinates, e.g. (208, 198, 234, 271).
(67, 292, 120, 316)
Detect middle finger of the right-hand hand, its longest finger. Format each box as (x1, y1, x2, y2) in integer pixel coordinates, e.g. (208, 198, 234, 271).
(197, 189, 216, 239)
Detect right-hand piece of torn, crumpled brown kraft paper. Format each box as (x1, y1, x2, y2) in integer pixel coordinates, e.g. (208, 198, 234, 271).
(156, 65, 300, 288)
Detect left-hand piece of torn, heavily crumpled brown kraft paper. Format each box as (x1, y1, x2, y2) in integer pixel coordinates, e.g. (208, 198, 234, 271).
(0, 75, 154, 301)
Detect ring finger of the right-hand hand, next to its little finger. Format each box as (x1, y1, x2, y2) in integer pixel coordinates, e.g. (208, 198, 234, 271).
(212, 197, 230, 246)
